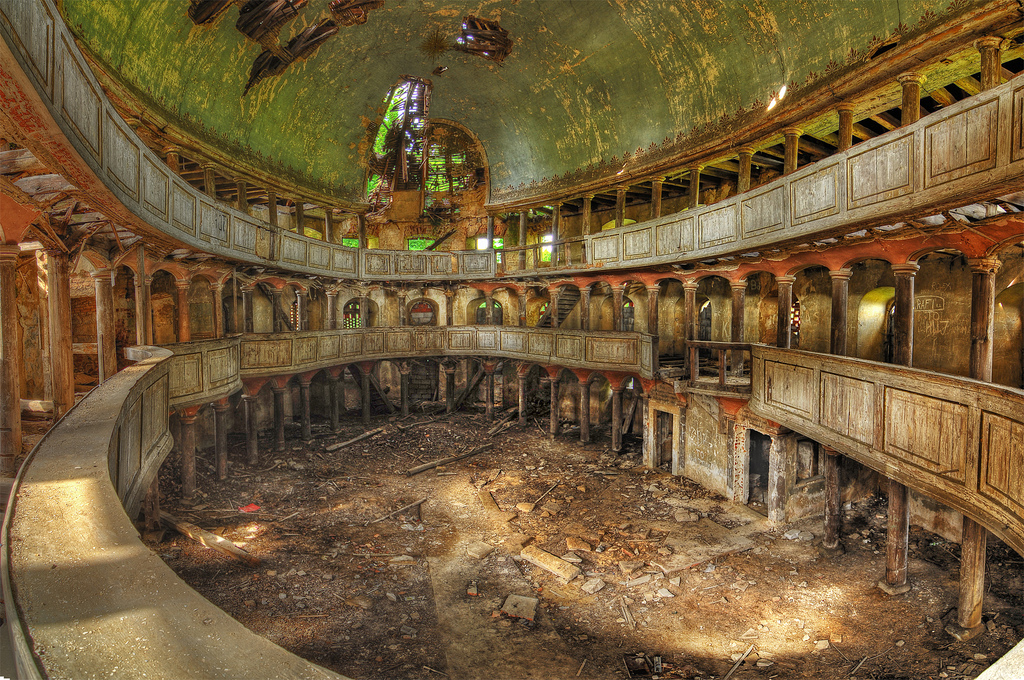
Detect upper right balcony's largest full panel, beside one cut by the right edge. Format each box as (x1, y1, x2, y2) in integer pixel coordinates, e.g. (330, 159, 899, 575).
(925, 99, 999, 186)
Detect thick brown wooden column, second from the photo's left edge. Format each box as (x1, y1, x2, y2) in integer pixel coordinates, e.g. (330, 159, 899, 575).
(45, 250, 74, 419)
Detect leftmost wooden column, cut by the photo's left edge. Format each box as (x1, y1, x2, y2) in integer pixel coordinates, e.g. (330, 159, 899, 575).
(0, 245, 21, 477)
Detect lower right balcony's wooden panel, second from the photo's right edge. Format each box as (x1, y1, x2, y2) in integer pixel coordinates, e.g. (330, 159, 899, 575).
(884, 386, 969, 481)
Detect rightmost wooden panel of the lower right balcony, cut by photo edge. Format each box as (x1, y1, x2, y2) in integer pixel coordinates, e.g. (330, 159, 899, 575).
(979, 413, 1024, 516)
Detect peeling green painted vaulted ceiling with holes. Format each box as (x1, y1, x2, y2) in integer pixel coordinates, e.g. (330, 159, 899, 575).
(62, 0, 949, 200)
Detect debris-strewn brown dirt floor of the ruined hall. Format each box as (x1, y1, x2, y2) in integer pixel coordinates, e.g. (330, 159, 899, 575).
(150, 405, 1024, 680)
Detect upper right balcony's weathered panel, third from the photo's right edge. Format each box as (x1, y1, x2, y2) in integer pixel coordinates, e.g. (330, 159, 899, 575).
(847, 134, 913, 208)
